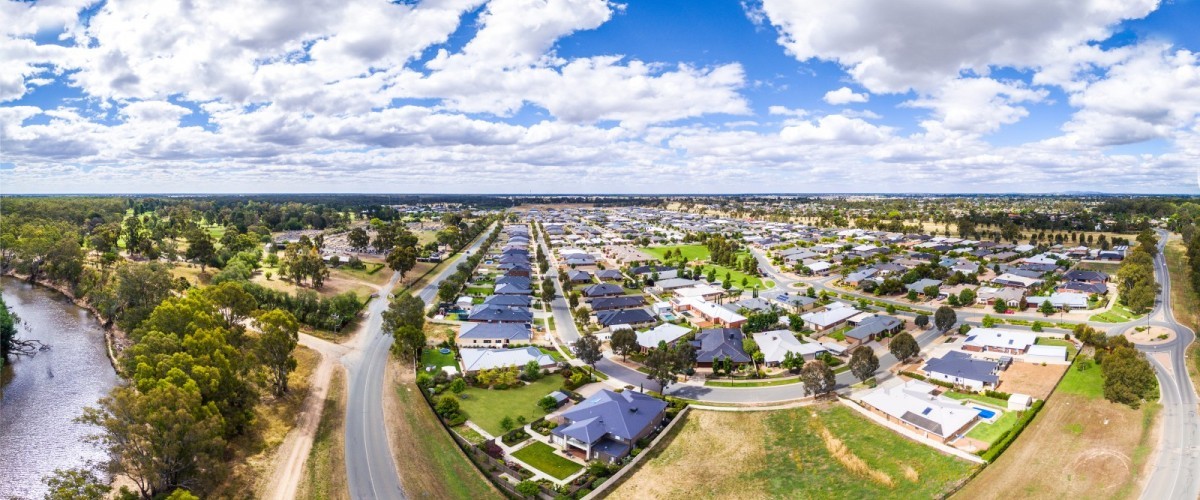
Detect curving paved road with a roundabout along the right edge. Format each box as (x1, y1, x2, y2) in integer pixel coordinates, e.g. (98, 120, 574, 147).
(1132, 231, 1200, 500)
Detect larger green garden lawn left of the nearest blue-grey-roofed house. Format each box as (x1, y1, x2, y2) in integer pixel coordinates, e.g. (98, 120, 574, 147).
(460, 374, 563, 435)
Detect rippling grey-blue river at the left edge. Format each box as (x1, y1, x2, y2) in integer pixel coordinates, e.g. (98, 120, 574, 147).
(0, 277, 119, 499)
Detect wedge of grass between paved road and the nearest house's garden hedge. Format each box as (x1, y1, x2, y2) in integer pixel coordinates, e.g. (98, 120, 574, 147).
(384, 363, 502, 499)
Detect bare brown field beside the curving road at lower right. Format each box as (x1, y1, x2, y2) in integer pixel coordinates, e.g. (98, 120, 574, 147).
(956, 363, 1158, 499)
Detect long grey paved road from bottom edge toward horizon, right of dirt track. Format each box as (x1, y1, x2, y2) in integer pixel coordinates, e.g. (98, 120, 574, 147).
(342, 227, 492, 499)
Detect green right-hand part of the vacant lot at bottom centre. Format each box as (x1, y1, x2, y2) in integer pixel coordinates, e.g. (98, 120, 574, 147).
(744, 405, 974, 499)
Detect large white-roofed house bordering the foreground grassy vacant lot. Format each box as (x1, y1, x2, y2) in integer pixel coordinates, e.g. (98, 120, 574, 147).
(862, 380, 979, 442)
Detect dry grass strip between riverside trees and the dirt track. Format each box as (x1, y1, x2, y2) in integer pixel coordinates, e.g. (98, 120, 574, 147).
(212, 347, 320, 498)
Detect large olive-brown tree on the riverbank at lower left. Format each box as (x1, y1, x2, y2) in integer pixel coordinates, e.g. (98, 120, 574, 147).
(79, 378, 226, 499)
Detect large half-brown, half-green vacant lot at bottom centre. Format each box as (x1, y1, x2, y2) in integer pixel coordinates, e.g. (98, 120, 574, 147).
(612, 404, 974, 499)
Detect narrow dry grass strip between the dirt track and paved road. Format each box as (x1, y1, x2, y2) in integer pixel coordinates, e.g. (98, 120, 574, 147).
(296, 368, 350, 499)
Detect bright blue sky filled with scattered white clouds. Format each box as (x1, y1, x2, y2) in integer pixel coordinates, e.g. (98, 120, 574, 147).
(0, 0, 1200, 194)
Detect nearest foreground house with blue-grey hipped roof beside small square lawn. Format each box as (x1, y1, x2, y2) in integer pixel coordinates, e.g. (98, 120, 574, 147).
(550, 388, 667, 463)
